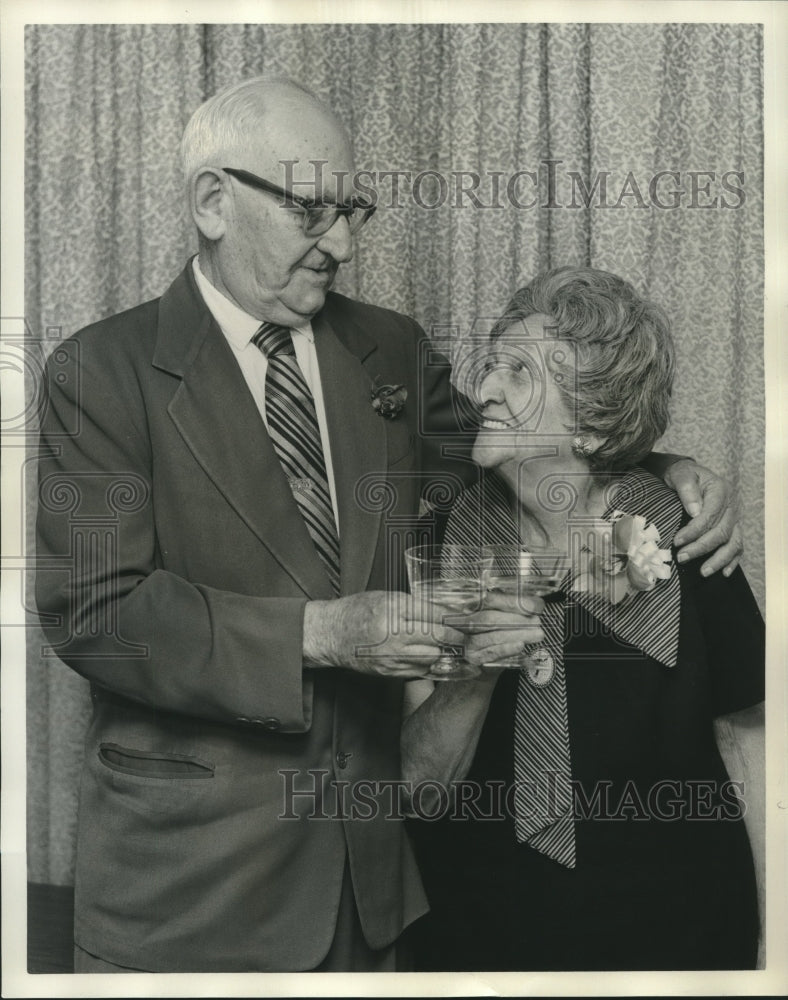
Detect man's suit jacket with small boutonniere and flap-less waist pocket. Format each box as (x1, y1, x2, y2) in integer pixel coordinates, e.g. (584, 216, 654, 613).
(37, 265, 468, 972)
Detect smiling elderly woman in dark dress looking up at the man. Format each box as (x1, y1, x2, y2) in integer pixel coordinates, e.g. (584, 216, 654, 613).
(403, 268, 764, 970)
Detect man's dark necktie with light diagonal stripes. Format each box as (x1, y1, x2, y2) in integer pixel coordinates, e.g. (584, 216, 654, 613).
(252, 323, 339, 594)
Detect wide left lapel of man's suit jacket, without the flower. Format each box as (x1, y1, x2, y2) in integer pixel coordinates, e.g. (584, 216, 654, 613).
(153, 262, 333, 600)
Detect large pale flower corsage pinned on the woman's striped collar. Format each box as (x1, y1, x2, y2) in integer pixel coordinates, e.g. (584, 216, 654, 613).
(573, 510, 673, 604)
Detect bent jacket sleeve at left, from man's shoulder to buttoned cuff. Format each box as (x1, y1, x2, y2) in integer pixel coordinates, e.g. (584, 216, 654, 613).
(36, 340, 312, 732)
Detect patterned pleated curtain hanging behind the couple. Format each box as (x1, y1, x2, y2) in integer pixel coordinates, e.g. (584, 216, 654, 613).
(26, 24, 764, 884)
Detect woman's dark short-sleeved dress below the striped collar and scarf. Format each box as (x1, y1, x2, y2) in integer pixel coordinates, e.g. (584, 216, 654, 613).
(411, 472, 764, 971)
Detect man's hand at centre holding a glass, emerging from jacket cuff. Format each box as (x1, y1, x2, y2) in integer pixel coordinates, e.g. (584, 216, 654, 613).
(304, 591, 464, 678)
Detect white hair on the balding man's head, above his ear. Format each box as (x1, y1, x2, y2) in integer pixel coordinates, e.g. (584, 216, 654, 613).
(180, 75, 326, 184)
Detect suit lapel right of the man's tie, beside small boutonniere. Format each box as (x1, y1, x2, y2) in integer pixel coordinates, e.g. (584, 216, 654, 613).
(312, 309, 387, 594)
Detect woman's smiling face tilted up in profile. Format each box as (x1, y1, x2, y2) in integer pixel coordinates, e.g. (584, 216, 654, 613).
(473, 313, 577, 476)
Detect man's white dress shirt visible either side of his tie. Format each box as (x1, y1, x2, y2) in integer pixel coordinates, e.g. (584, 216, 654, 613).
(193, 257, 339, 532)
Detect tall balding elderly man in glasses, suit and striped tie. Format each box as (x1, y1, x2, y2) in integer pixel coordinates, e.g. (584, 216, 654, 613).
(37, 78, 737, 972)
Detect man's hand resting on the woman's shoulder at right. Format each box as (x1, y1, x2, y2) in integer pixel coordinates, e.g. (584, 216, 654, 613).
(664, 458, 743, 576)
